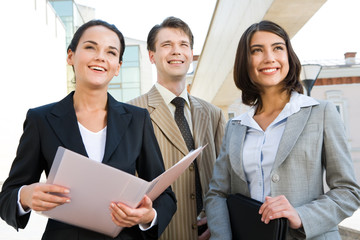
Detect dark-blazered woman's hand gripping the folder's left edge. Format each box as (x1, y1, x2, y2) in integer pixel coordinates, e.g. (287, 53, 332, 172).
(20, 183, 70, 211)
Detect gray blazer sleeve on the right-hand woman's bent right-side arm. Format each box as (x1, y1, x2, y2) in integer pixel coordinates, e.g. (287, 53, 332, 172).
(296, 103, 360, 238)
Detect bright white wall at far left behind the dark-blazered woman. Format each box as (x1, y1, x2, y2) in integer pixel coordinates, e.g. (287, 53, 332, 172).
(0, 0, 67, 180)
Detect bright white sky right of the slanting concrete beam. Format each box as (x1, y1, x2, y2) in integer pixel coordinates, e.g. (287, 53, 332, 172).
(291, 0, 360, 60)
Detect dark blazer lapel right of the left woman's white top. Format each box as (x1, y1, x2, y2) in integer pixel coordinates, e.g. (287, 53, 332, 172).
(103, 94, 132, 163)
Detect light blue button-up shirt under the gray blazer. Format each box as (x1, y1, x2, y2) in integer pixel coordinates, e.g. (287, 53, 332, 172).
(234, 91, 319, 202)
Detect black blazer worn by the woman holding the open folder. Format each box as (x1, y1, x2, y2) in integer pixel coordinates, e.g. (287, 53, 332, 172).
(0, 92, 176, 240)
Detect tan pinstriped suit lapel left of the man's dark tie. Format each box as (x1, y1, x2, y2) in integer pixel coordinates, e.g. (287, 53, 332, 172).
(148, 86, 189, 155)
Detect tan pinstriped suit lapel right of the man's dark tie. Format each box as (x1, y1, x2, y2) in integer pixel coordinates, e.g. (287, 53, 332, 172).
(189, 95, 210, 165)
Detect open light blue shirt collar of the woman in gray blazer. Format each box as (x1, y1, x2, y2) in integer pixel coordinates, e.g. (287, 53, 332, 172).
(232, 91, 319, 126)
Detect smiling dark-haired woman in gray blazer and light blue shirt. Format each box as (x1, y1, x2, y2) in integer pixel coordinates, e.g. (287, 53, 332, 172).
(206, 21, 360, 240)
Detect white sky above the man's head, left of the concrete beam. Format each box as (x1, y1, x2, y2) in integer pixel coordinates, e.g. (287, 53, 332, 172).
(75, 0, 216, 55)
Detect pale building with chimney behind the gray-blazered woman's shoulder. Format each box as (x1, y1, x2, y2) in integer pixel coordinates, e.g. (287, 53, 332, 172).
(311, 53, 360, 176)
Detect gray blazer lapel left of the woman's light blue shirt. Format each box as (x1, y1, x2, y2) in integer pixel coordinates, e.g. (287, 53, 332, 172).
(231, 121, 247, 182)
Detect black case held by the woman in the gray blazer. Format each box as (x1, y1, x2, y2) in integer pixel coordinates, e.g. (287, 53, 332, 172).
(226, 193, 288, 240)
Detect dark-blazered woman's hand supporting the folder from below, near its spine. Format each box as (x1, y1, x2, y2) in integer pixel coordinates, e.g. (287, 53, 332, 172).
(110, 196, 155, 227)
